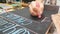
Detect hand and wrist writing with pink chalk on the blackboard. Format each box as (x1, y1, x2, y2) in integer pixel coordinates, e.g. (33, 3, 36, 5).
(29, 0, 44, 18)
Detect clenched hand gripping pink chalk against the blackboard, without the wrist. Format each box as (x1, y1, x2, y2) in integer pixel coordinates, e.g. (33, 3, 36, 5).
(29, 1, 43, 18)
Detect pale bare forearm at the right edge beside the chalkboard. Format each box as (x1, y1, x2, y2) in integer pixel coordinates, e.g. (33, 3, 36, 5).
(51, 14, 60, 34)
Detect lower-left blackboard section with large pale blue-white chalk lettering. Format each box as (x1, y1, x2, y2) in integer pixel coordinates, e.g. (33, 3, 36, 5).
(0, 17, 35, 34)
